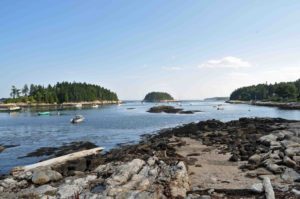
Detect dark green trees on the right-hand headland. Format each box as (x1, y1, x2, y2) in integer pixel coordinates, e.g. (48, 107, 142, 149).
(230, 79, 300, 102)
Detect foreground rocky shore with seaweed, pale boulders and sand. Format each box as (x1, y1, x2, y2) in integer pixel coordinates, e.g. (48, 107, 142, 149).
(0, 118, 300, 199)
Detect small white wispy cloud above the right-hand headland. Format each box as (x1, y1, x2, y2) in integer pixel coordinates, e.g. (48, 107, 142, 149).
(198, 56, 251, 69)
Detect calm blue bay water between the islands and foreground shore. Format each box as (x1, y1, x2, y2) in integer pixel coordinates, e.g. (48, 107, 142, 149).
(0, 101, 300, 173)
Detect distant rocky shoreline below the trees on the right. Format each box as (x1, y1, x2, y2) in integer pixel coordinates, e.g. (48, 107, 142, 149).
(226, 100, 300, 110)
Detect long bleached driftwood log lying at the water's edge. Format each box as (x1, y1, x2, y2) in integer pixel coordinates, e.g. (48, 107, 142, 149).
(11, 147, 104, 175)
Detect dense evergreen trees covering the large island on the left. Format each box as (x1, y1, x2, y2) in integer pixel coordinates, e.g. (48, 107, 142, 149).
(6, 82, 118, 103)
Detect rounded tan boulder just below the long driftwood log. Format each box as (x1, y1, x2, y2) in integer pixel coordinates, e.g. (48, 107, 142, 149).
(31, 168, 62, 185)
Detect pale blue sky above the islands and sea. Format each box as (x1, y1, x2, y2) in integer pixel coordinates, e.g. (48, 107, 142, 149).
(0, 0, 300, 100)
